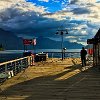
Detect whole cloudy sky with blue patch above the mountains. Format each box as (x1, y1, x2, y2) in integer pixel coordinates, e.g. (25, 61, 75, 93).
(0, 0, 100, 44)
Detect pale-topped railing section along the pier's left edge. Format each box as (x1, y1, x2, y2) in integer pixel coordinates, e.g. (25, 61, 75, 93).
(0, 56, 34, 78)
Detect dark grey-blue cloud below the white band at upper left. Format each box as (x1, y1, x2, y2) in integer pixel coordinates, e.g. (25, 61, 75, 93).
(0, 8, 47, 29)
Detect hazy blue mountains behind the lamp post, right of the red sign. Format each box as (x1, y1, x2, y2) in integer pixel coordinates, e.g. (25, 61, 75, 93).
(35, 37, 83, 49)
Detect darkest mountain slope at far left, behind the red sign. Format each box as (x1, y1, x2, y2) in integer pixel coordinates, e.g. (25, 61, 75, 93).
(0, 28, 23, 50)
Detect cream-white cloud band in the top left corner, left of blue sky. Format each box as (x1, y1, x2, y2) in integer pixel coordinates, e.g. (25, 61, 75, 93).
(0, 0, 45, 13)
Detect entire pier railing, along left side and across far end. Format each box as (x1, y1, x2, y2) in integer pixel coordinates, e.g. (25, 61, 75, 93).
(0, 52, 93, 78)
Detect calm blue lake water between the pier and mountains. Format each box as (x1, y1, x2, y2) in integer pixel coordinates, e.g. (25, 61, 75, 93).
(0, 49, 80, 63)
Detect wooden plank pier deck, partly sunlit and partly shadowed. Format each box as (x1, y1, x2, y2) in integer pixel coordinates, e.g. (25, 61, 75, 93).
(0, 59, 100, 100)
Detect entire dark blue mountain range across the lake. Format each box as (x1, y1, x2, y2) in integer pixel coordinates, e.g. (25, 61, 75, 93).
(0, 28, 83, 50)
